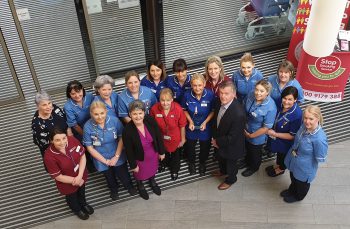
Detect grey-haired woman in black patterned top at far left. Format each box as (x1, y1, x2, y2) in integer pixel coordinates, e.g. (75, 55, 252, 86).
(32, 90, 72, 162)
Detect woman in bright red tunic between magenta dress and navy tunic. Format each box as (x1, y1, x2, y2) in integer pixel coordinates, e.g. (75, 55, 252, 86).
(150, 88, 187, 180)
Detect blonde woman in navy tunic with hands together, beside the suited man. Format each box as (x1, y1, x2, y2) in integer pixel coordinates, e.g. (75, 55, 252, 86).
(181, 73, 215, 176)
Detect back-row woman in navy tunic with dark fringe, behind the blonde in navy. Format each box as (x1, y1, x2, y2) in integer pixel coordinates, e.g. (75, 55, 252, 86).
(165, 59, 191, 103)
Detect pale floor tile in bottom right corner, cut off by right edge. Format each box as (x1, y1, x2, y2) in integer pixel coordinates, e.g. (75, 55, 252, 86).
(313, 204, 350, 225)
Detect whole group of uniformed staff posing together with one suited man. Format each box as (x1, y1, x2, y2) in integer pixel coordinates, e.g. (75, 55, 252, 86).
(32, 53, 327, 220)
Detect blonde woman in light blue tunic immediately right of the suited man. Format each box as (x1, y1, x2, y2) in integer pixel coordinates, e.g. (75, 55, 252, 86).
(242, 80, 277, 177)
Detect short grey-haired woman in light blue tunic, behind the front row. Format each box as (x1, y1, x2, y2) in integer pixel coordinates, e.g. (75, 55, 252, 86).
(94, 75, 118, 117)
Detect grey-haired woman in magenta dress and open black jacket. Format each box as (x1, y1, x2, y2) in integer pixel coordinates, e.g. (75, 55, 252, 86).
(123, 100, 165, 200)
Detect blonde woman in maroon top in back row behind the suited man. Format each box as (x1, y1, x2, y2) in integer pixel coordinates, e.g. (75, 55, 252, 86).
(204, 56, 230, 98)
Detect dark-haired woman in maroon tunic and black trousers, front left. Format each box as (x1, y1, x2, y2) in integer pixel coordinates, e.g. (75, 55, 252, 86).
(44, 127, 94, 220)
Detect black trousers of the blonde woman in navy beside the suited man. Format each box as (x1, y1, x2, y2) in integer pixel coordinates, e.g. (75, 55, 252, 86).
(185, 139, 211, 164)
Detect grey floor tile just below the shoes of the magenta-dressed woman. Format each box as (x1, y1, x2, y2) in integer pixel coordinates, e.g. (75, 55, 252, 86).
(127, 199, 175, 222)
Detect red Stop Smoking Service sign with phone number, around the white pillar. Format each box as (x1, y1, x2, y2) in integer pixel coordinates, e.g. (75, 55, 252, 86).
(296, 50, 350, 102)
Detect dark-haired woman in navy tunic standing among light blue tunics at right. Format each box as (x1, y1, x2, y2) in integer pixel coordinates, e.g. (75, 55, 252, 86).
(265, 86, 303, 177)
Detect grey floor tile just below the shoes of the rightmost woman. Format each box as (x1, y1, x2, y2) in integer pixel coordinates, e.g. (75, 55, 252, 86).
(267, 203, 315, 224)
